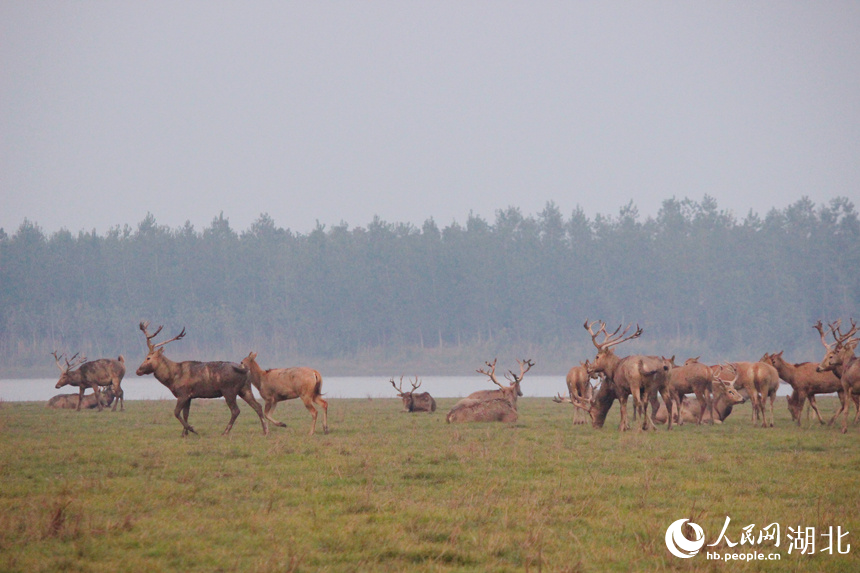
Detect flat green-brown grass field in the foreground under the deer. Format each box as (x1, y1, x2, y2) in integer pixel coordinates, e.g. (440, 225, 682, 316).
(0, 398, 860, 573)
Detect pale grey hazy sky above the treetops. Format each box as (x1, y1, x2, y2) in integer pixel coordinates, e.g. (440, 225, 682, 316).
(0, 0, 860, 233)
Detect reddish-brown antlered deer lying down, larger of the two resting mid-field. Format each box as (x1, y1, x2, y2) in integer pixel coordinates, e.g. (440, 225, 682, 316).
(445, 359, 534, 424)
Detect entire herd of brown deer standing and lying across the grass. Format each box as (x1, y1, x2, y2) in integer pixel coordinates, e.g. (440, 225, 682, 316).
(48, 318, 860, 436)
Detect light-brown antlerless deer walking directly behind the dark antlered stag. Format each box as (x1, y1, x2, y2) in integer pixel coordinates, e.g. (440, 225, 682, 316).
(242, 352, 328, 436)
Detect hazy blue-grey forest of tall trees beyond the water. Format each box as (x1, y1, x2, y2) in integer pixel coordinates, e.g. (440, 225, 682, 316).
(0, 196, 860, 377)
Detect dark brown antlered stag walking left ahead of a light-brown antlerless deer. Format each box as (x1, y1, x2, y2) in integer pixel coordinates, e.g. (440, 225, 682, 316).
(137, 322, 269, 438)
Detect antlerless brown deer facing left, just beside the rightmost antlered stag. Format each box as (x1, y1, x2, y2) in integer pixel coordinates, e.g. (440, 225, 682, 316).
(761, 350, 847, 426)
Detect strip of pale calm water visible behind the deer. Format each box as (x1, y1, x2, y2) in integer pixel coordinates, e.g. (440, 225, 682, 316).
(0, 376, 791, 402)
